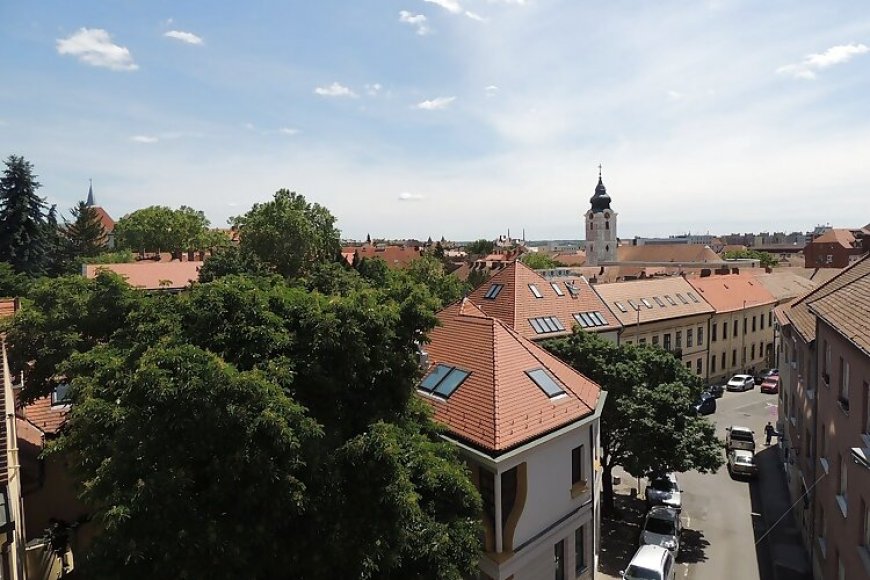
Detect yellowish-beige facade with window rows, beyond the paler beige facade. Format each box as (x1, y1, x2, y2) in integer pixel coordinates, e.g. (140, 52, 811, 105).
(708, 304, 774, 382)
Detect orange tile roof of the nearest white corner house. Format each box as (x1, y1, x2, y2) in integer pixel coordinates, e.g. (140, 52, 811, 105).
(418, 299, 601, 453)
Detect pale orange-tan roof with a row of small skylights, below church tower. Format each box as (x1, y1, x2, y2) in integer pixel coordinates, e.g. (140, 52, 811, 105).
(594, 276, 714, 326)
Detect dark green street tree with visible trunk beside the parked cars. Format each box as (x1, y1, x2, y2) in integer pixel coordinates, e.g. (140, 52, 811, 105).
(544, 329, 723, 513)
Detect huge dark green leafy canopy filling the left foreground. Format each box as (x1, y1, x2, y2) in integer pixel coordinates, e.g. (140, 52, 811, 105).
(6, 274, 481, 579)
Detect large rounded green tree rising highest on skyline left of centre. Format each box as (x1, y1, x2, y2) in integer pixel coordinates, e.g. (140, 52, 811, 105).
(233, 189, 341, 278)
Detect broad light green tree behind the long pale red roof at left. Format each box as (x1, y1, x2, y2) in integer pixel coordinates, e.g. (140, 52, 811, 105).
(115, 205, 215, 258)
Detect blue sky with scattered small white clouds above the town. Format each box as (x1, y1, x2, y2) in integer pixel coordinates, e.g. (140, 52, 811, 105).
(0, 0, 870, 240)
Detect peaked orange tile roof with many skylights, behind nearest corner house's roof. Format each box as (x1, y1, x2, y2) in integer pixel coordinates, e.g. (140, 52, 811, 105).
(468, 262, 620, 340)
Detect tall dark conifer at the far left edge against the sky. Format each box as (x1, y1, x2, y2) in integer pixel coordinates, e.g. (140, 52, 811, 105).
(0, 155, 56, 276)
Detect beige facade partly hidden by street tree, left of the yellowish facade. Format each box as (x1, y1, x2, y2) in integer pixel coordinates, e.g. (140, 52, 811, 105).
(621, 314, 710, 381)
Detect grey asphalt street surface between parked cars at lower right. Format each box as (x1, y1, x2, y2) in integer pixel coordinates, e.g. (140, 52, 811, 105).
(677, 387, 788, 580)
